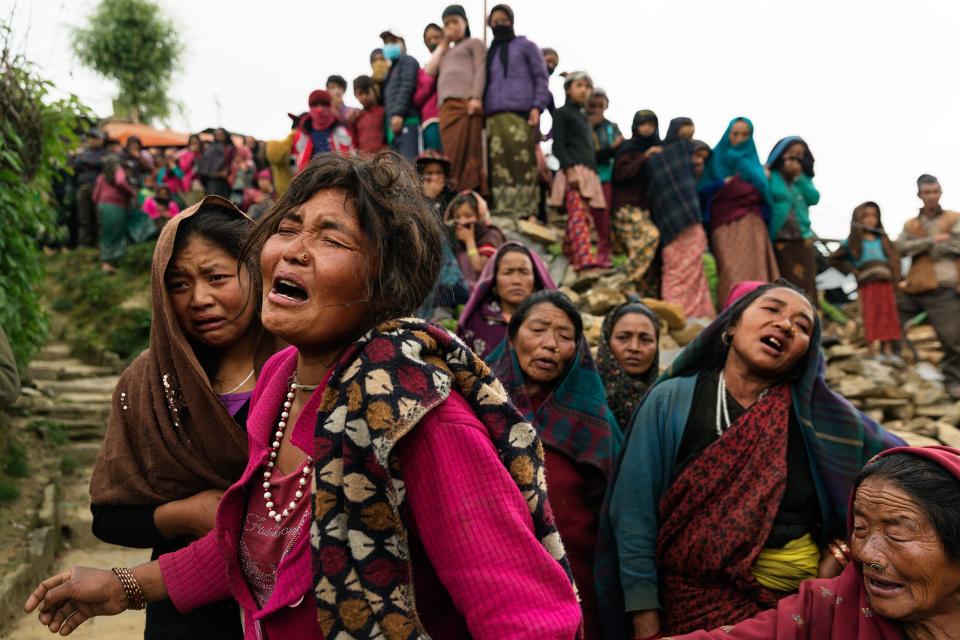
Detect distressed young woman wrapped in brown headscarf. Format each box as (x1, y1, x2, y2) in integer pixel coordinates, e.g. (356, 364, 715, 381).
(90, 196, 275, 639)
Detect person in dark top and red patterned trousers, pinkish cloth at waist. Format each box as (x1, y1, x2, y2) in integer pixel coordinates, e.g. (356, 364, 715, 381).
(549, 71, 613, 272)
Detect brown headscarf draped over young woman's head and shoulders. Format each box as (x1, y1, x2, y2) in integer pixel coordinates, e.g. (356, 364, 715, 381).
(90, 196, 275, 505)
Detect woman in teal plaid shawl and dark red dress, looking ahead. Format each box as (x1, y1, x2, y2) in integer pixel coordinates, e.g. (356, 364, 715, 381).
(487, 291, 623, 639)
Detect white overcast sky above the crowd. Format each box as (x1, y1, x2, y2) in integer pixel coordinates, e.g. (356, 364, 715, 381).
(7, 0, 960, 237)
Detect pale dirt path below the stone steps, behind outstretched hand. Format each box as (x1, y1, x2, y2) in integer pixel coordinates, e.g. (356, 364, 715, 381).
(3, 543, 150, 640)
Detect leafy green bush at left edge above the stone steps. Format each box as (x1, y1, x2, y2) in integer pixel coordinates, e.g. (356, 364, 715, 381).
(0, 23, 88, 367)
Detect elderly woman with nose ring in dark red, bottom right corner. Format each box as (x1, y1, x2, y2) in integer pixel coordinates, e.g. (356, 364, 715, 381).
(675, 447, 960, 640)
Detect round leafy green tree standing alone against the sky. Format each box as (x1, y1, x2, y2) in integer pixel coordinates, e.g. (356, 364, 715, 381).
(73, 0, 182, 122)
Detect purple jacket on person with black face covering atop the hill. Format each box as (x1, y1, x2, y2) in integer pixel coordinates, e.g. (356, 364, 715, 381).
(483, 36, 550, 116)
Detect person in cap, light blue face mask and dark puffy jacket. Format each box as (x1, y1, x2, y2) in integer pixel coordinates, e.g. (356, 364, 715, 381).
(380, 29, 420, 160)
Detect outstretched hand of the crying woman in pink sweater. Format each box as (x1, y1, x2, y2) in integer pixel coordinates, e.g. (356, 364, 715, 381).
(23, 567, 129, 636)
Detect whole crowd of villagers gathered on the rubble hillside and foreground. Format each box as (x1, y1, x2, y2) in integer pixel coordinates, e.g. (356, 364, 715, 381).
(26, 5, 960, 640)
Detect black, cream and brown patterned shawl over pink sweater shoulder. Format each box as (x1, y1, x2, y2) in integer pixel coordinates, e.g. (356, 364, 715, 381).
(311, 319, 572, 640)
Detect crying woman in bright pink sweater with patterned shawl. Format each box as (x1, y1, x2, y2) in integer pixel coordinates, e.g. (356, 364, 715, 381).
(26, 153, 581, 640)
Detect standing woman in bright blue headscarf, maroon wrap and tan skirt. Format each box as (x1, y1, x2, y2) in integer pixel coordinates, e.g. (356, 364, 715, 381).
(697, 117, 780, 308)
